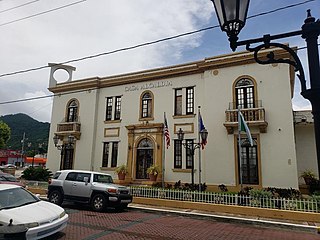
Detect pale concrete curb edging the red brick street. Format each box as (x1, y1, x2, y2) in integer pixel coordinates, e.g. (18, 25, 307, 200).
(128, 204, 320, 233)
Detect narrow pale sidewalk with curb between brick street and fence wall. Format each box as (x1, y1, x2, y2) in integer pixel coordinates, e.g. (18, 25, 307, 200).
(129, 203, 320, 234)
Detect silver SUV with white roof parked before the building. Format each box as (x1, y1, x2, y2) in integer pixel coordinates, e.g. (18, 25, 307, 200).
(48, 170, 132, 212)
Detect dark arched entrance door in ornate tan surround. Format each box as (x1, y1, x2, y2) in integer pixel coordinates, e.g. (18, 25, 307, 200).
(136, 139, 153, 179)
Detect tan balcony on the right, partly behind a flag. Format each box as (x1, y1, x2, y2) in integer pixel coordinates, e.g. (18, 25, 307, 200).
(223, 101, 268, 134)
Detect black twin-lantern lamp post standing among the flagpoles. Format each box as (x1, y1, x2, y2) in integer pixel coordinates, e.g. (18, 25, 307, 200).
(177, 128, 208, 186)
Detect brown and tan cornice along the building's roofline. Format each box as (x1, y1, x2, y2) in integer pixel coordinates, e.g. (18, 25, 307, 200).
(48, 49, 294, 93)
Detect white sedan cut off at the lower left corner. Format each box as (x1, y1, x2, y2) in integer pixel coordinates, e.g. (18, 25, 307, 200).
(0, 184, 68, 239)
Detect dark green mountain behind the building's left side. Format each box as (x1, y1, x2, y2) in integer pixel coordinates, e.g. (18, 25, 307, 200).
(0, 113, 50, 152)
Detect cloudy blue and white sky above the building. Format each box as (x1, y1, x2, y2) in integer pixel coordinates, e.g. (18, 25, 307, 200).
(0, 0, 320, 122)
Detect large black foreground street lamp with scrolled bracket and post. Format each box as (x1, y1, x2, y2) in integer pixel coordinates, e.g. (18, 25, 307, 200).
(211, 0, 320, 176)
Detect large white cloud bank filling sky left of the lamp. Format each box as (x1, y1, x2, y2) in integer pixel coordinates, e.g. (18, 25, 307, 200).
(0, 0, 212, 121)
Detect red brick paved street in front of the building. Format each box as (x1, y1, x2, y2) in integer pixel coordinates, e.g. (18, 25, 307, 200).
(57, 204, 320, 240)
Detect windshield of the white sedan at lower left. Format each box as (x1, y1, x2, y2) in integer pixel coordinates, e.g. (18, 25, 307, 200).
(0, 188, 40, 210)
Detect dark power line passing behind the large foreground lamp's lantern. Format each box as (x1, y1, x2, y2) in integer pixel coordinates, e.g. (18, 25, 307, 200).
(0, 0, 316, 78)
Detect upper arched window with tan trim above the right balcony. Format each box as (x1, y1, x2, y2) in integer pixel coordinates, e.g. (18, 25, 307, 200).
(235, 77, 256, 109)
